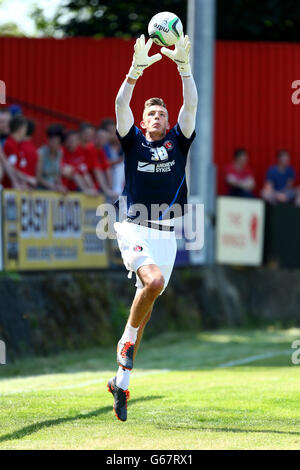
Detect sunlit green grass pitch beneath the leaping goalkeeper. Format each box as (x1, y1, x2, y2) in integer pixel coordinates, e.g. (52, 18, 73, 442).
(0, 329, 300, 450)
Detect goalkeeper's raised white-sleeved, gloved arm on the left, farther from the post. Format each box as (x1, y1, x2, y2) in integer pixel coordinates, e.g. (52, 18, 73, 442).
(116, 34, 162, 137)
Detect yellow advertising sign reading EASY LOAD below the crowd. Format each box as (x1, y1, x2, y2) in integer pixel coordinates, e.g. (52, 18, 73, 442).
(3, 190, 108, 271)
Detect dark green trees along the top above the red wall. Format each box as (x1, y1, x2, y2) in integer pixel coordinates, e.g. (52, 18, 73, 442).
(33, 0, 300, 41)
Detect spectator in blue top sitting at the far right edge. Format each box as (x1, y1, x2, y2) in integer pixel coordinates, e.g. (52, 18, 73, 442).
(261, 150, 300, 206)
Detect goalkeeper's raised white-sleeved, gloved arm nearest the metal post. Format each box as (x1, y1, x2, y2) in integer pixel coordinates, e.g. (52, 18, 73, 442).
(161, 35, 198, 138)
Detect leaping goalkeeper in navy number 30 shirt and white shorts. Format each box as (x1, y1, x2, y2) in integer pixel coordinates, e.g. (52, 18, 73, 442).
(107, 35, 198, 421)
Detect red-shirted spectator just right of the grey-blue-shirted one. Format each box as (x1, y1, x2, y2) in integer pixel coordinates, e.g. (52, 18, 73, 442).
(62, 130, 98, 196)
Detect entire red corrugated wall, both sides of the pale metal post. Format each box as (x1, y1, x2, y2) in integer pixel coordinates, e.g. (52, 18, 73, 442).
(0, 38, 300, 195)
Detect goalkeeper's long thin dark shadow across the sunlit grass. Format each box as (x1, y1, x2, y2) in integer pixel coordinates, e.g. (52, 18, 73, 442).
(0, 396, 162, 443)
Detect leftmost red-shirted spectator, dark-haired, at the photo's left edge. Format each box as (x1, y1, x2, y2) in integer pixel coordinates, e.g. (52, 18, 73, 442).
(3, 116, 36, 190)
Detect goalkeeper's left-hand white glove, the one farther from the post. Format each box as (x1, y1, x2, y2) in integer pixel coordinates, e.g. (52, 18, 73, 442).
(127, 34, 162, 80)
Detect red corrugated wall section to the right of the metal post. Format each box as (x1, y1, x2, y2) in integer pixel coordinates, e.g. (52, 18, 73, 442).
(214, 41, 300, 193)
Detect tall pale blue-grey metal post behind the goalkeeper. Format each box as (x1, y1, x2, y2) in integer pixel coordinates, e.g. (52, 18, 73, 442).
(188, 0, 216, 264)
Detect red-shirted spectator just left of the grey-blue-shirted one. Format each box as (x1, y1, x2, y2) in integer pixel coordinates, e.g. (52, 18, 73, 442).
(20, 119, 38, 187)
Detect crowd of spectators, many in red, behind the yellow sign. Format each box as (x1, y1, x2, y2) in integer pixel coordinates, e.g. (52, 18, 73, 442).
(0, 107, 124, 199)
